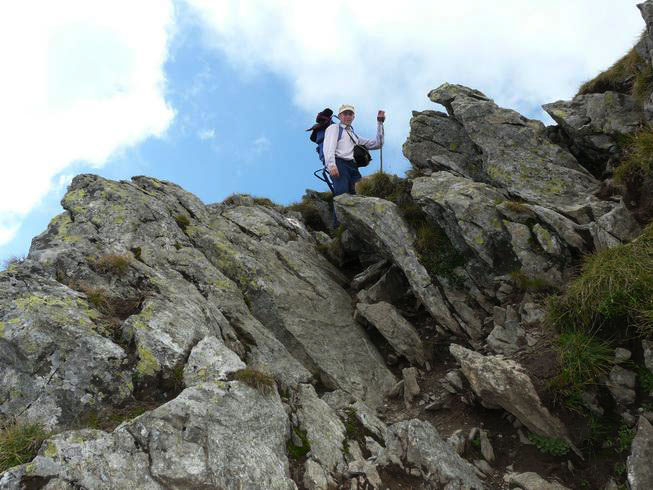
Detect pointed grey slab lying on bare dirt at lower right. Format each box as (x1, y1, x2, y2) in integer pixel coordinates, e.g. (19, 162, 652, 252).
(449, 344, 573, 447)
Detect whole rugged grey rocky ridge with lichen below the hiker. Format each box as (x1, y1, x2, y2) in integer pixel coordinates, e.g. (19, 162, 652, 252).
(0, 0, 653, 489)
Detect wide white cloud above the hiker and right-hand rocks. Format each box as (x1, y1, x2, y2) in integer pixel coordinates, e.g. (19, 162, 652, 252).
(187, 0, 644, 171)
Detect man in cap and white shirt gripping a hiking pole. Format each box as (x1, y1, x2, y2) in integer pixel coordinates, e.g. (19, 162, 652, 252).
(323, 104, 385, 197)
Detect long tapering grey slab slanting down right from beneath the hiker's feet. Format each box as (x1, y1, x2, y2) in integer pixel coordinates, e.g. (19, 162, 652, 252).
(335, 194, 465, 335)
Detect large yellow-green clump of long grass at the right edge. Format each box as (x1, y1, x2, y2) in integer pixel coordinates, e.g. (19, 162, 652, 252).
(547, 225, 653, 337)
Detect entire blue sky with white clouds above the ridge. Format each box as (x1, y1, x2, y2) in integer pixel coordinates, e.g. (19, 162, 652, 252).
(0, 0, 643, 262)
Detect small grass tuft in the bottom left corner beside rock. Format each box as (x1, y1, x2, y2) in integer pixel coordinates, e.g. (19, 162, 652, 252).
(0, 422, 48, 473)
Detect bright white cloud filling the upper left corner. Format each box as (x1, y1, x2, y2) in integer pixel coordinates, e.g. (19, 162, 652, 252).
(0, 0, 174, 245)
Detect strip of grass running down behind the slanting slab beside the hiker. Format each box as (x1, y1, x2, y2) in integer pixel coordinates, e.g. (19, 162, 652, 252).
(356, 172, 465, 284)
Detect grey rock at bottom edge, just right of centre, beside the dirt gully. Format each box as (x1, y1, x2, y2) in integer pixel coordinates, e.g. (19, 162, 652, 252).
(377, 419, 484, 490)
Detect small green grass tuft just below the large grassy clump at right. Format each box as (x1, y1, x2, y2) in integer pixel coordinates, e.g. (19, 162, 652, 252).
(553, 330, 614, 396)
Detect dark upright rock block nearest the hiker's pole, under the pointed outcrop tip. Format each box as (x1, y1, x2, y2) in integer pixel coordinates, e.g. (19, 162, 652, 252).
(403, 111, 486, 180)
